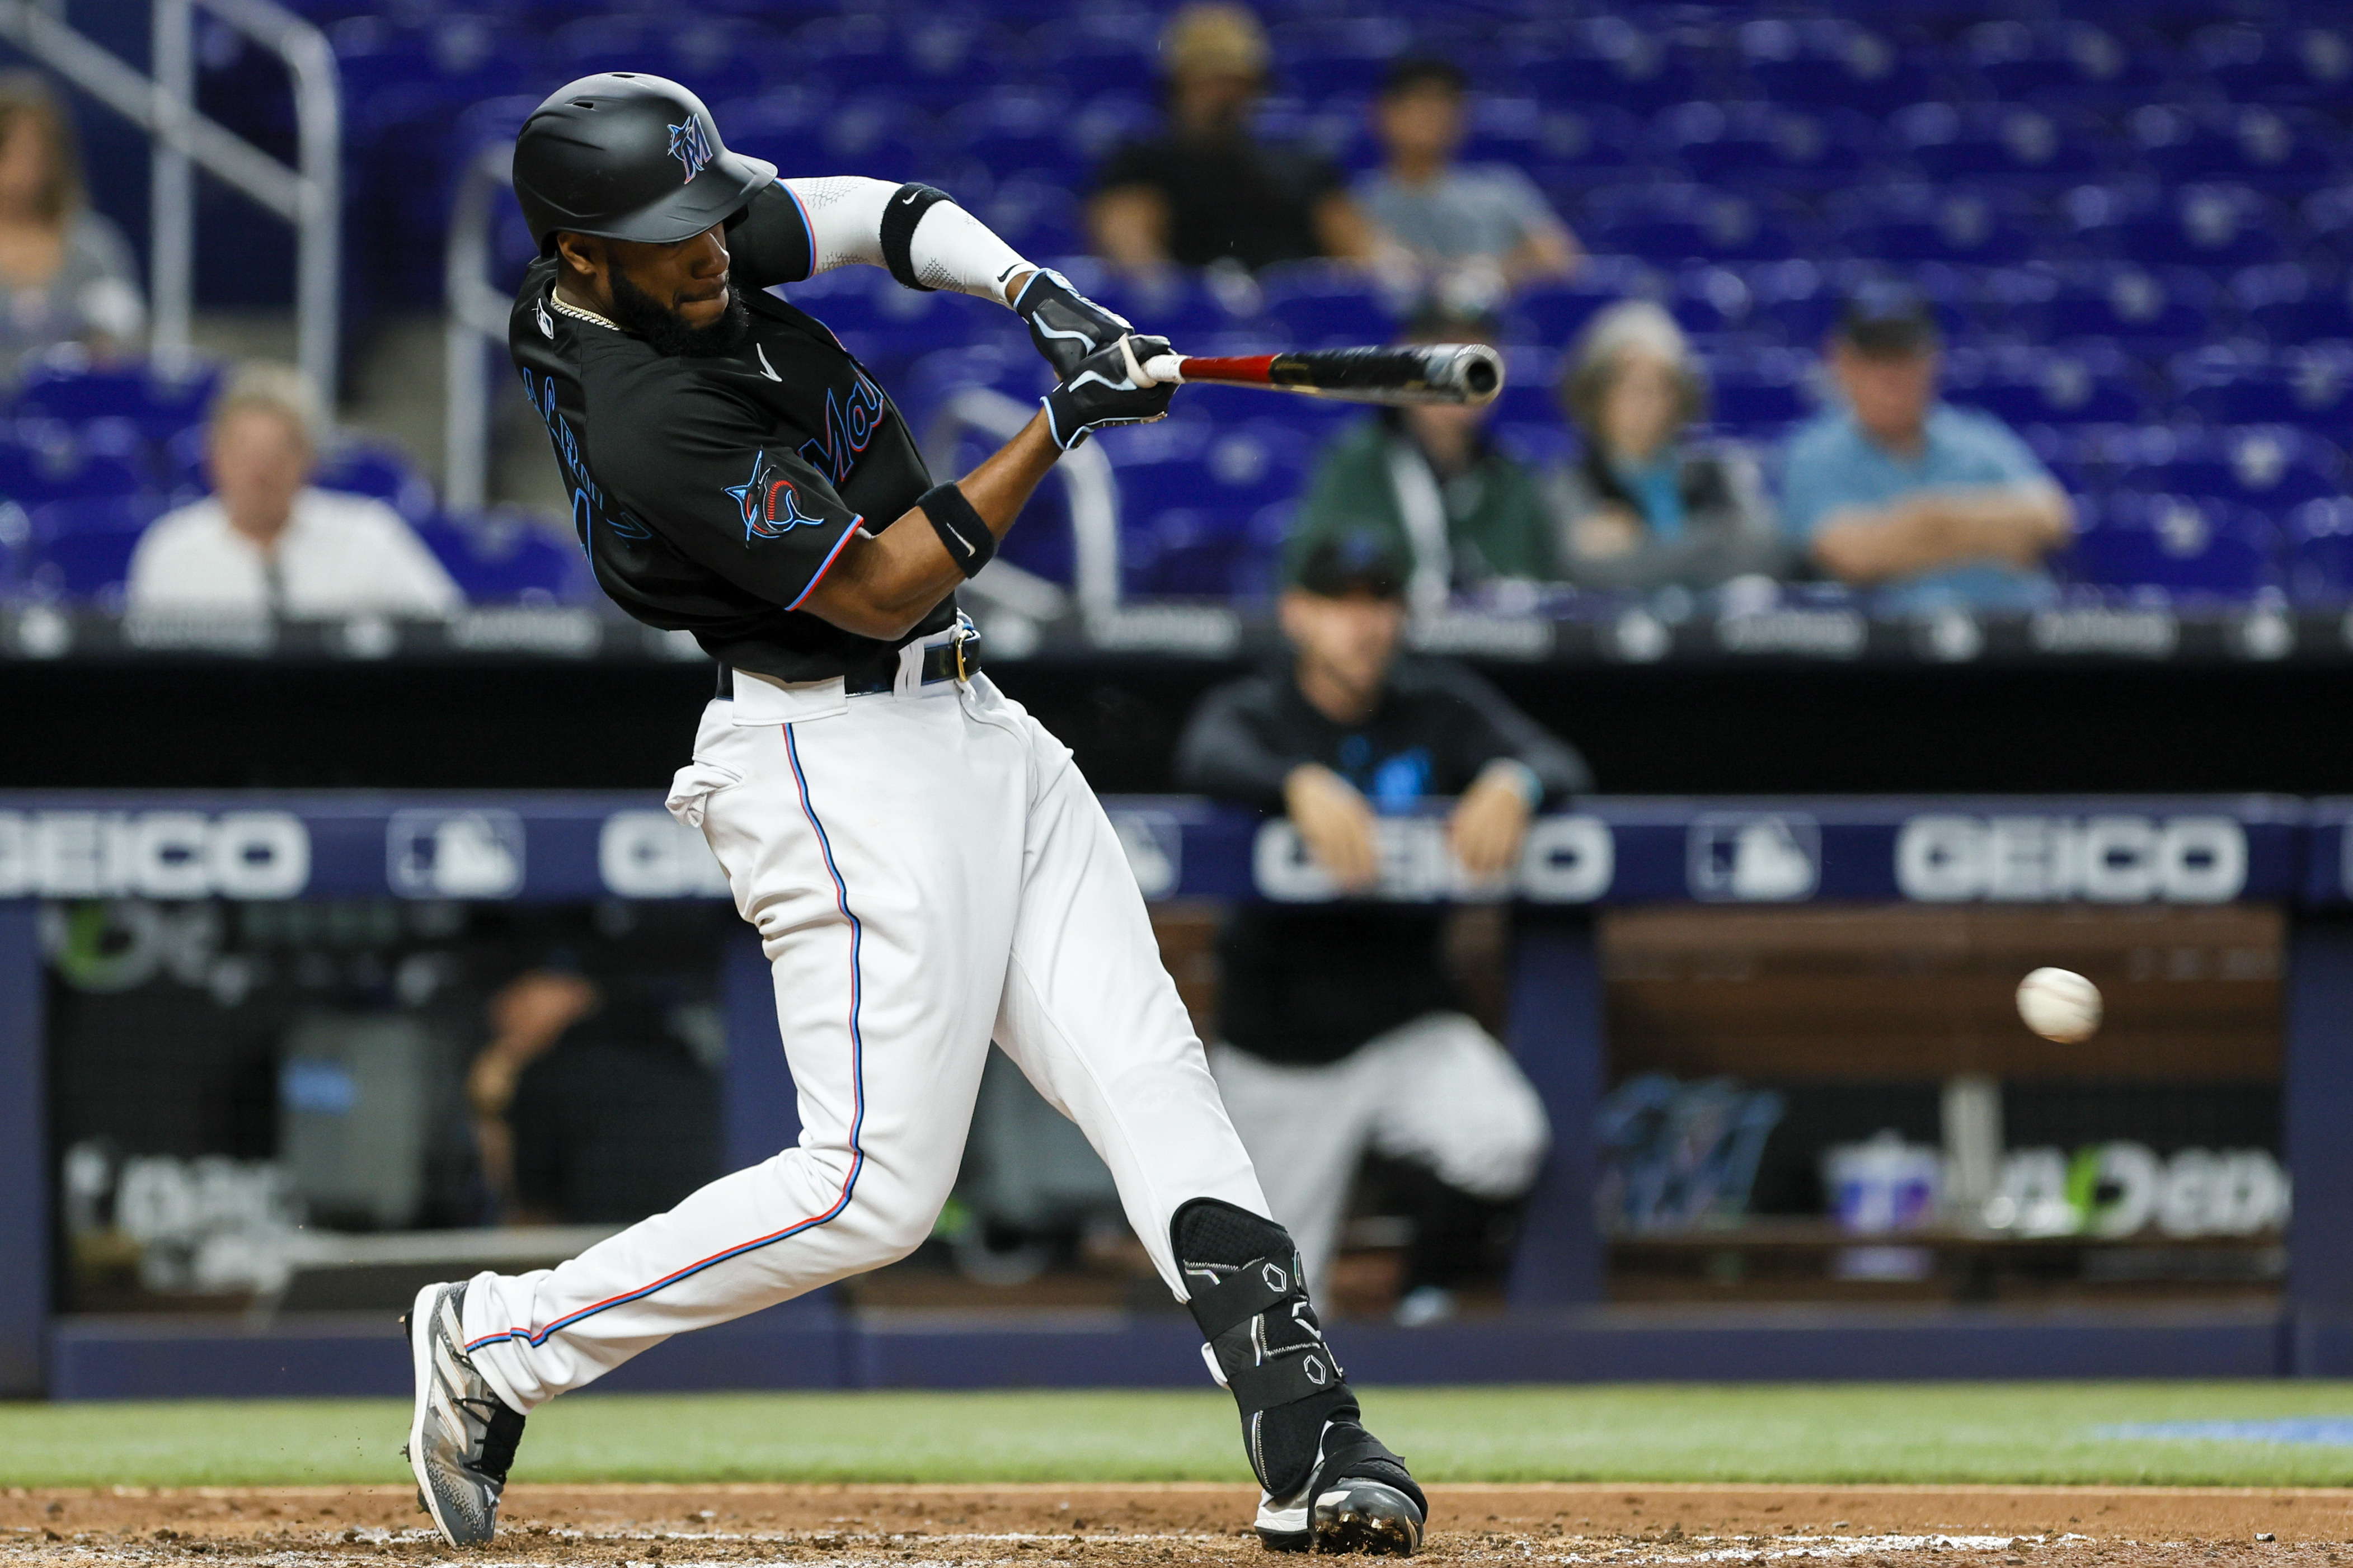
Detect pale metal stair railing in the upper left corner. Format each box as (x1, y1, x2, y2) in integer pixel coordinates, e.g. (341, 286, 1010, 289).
(0, 0, 344, 402)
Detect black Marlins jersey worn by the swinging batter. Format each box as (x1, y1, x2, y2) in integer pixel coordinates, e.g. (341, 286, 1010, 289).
(506, 183, 955, 682)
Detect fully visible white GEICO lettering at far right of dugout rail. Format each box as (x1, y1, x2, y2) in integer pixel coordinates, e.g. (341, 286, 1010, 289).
(1896, 816, 2247, 903)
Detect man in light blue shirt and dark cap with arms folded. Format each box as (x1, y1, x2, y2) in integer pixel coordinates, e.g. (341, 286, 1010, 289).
(1781, 284, 2075, 609)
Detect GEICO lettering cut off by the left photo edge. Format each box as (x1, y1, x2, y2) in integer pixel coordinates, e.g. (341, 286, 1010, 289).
(0, 811, 311, 898)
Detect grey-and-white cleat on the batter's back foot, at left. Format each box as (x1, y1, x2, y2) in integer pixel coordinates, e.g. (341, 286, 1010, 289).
(400, 1286, 523, 1547)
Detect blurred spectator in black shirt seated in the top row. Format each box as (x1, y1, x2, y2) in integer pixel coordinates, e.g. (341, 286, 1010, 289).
(1087, 2, 1377, 270)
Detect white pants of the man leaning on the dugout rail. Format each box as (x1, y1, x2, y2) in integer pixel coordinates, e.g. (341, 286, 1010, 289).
(1209, 1013, 1553, 1293)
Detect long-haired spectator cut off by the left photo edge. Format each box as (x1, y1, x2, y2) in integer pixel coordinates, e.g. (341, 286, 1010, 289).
(0, 70, 146, 374)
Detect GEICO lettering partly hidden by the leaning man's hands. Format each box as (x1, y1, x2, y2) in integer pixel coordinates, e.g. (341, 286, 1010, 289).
(1250, 816, 1617, 903)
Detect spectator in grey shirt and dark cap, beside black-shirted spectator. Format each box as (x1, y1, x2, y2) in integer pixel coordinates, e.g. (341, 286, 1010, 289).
(1355, 56, 1584, 299)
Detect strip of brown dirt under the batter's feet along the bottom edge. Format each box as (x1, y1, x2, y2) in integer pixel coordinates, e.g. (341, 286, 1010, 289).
(0, 1486, 2353, 1568)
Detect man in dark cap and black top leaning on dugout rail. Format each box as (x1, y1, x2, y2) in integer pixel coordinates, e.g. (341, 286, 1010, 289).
(1177, 531, 1593, 1321)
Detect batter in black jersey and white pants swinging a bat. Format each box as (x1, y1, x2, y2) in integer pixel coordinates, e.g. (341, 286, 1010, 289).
(407, 73, 1426, 1554)
